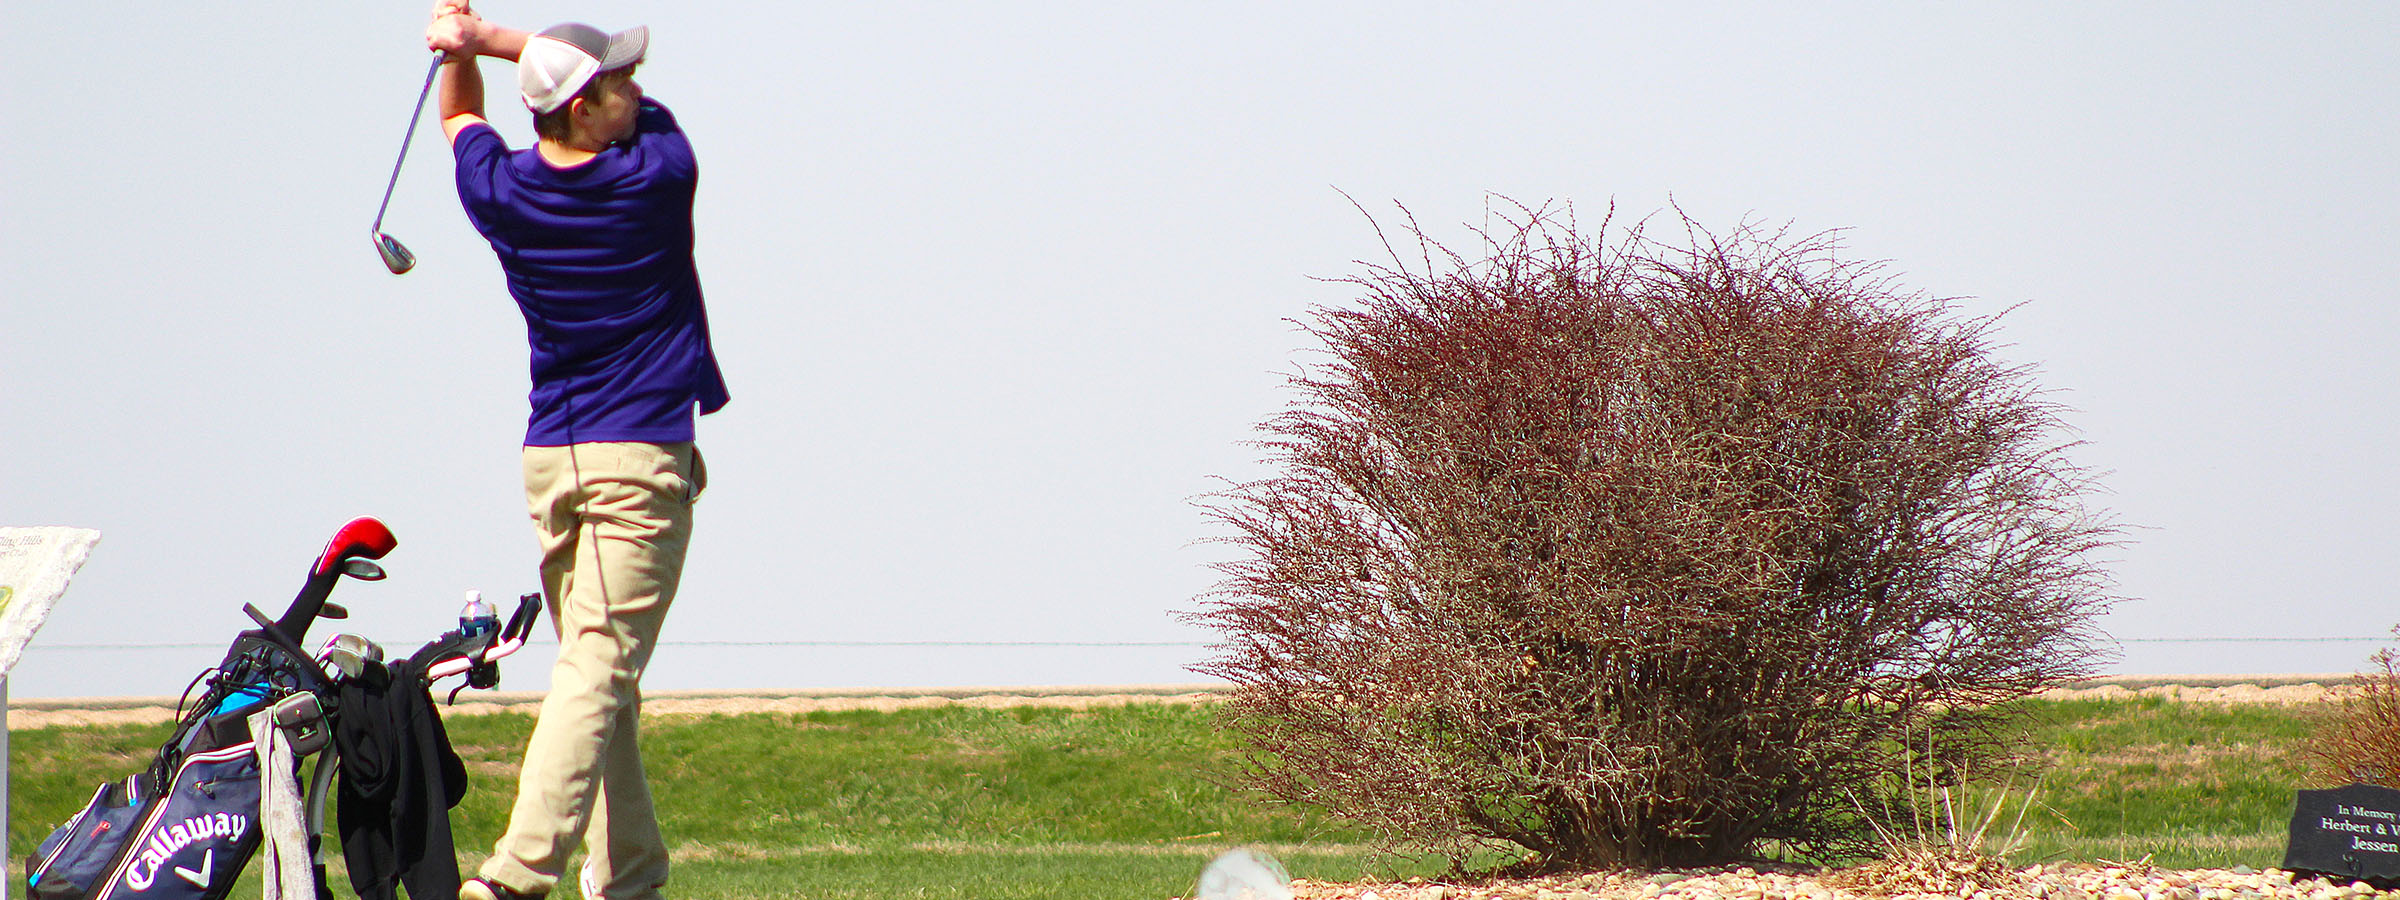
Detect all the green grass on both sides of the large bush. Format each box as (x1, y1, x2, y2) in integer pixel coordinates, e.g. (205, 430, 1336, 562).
(10, 701, 2342, 900)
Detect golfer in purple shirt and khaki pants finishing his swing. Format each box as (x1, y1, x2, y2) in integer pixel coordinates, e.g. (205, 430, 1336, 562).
(425, 0, 727, 900)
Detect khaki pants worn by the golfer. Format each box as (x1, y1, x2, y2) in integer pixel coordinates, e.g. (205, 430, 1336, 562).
(480, 442, 708, 900)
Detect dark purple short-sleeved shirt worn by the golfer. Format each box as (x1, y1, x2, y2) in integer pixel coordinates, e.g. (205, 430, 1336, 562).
(451, 98, 727, 446)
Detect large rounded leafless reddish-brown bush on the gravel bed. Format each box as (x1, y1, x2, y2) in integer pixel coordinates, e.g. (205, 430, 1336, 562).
(1193, 206, 2114, 866)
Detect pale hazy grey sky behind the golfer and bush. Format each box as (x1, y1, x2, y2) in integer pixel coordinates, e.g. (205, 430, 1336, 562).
(0, 0, 2400, 696)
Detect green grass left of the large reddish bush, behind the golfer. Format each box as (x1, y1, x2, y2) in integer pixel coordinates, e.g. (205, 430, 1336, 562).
(10, 703, 1411, 898)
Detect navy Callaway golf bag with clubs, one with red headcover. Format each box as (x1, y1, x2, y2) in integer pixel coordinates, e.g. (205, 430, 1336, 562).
(24, 518, 540, 900)
